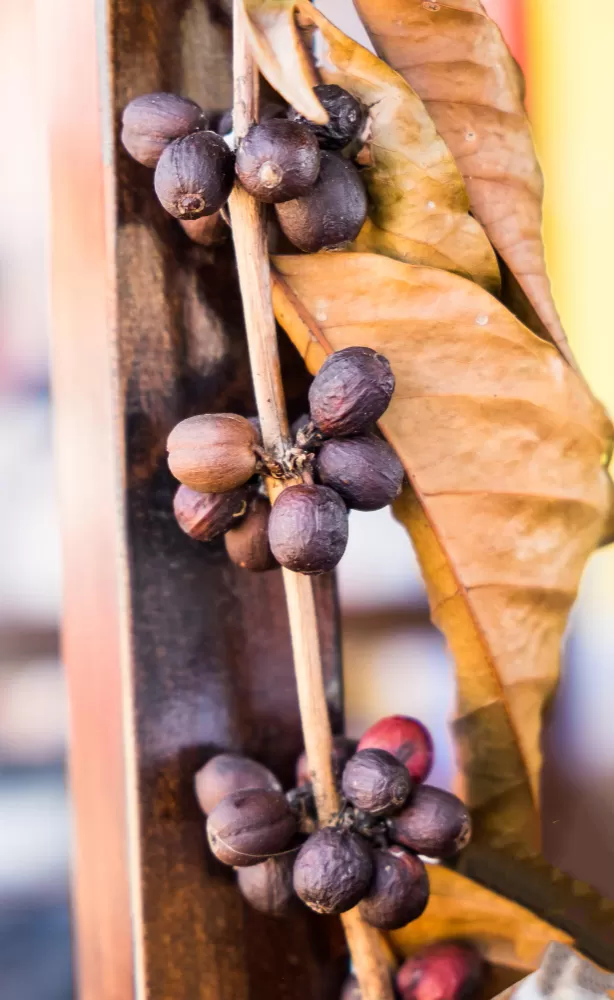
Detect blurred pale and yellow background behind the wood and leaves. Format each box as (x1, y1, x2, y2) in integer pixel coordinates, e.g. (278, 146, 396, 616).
(0, 0, 614, 1000)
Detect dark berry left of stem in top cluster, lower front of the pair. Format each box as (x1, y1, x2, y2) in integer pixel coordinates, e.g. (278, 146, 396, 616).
(154, 132, 234, 219)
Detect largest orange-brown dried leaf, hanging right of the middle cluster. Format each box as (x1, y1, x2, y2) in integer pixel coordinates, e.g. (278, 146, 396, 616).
(274, 254, 611, 856)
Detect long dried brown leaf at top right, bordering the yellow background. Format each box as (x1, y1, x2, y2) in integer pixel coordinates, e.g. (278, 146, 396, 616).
(356, 0, 574, 364)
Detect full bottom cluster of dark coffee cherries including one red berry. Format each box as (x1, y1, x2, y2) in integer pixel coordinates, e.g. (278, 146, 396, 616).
(195, 716, 470, 930)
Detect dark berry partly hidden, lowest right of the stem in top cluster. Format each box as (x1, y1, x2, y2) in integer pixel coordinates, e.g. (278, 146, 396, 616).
(275, 152, 367, 253)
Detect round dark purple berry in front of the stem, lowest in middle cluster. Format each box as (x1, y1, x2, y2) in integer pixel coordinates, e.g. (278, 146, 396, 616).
(269, 486, 348, 574)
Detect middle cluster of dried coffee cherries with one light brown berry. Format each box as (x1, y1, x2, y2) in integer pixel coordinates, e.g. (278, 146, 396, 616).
(168, 347, 403, 574)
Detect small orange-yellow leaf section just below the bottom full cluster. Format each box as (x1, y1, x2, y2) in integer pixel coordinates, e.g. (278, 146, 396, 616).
(389, 865, 572, 971)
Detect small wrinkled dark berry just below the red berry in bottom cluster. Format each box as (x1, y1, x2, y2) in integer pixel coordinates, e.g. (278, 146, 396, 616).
(341, 750, 411, 816)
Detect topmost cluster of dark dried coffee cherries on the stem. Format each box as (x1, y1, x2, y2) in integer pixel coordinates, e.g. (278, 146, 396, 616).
(122, 84, 367, 253)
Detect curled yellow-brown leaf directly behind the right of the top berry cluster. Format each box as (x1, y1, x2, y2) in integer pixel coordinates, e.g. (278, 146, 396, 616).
(309, 9, 500, 293)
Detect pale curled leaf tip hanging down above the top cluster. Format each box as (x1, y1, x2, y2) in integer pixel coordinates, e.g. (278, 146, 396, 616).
(243, 0, 328, 123)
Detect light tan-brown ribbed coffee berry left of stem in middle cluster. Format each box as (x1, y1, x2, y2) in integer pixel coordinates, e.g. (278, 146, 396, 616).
(167, 413, 258, 493)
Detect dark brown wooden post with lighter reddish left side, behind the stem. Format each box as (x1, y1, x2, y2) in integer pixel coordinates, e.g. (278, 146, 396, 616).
(40, 0, 344, 1000)
